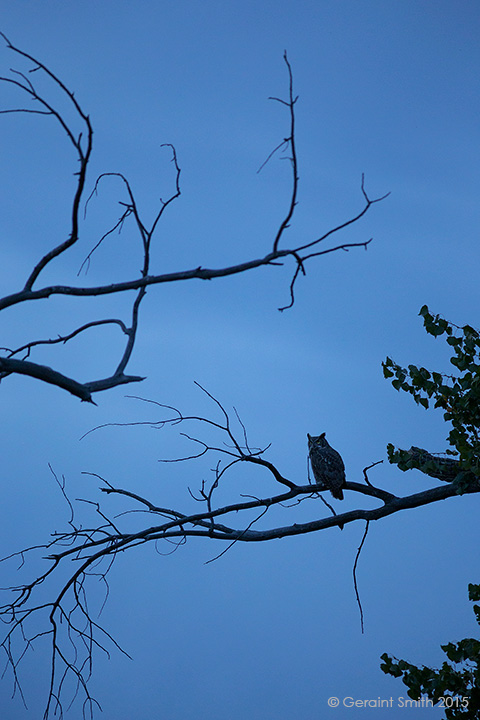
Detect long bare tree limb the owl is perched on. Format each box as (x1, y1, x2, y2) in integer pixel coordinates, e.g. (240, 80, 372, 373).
(0, 388, 480, 718)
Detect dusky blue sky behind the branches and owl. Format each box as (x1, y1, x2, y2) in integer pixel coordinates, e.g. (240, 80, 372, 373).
(0, 0, 480, 720)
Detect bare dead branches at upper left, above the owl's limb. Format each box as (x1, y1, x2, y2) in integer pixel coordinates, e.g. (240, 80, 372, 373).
(0, 33, 386, 403)
